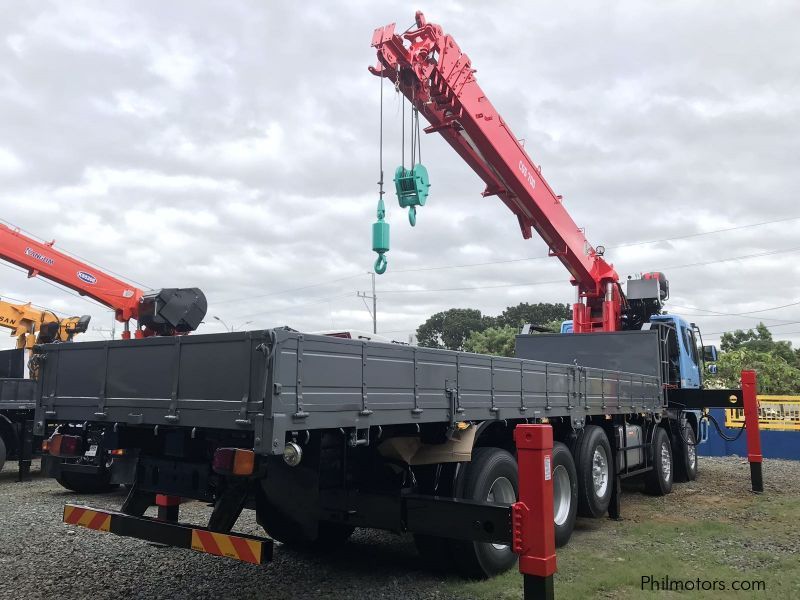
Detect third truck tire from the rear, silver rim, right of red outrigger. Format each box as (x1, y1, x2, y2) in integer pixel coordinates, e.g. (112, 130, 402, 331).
(575, 425, 614, 519)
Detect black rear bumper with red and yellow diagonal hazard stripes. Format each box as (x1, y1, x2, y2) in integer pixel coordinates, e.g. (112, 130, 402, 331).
(64, 504, 272, 565)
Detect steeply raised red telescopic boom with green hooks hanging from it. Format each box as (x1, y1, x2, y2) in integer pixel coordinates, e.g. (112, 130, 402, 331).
(370, 12, 624, 333)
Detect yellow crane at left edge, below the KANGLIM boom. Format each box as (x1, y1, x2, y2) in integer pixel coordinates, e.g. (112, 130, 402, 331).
(0, 300, 90, 349)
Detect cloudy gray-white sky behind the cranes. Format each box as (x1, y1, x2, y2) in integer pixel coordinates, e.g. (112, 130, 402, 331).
(0, 0, 800, 348)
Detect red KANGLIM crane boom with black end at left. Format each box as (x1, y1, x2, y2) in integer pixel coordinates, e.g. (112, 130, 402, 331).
(0, 223, 206, 339)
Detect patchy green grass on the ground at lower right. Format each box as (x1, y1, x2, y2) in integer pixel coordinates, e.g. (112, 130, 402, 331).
(448, 473, 800, 600)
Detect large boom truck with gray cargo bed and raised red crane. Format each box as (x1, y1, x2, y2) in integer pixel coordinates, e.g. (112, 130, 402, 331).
(29, 13, 742, 577)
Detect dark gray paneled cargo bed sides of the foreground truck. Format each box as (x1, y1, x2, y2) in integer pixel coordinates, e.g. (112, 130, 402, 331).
(37, 329, 664, 454)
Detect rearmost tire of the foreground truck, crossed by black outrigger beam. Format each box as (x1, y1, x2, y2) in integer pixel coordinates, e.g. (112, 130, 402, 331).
(450, 448, 519, 579)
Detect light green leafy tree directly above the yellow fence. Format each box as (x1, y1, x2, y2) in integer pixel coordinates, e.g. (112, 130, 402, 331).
(709, 347, 800, 394)
